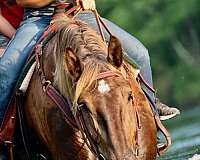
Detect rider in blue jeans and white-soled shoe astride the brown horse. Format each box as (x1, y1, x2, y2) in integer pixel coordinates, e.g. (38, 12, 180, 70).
(0, 0, 179, 124)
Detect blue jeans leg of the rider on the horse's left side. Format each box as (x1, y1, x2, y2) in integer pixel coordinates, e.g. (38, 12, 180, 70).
(0, 14, 51, 121)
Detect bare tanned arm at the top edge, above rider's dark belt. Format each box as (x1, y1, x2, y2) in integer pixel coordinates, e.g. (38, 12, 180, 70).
(16, 0, 55, 8)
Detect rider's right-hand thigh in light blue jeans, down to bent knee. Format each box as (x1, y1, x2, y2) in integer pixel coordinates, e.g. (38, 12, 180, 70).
(77, 11, 150, 67)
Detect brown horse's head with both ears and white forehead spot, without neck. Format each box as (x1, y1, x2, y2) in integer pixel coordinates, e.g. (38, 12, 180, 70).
(62, 34, 142, 160)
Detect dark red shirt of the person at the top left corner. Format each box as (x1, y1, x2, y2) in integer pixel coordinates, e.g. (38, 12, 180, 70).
(0, 0, 24, 28)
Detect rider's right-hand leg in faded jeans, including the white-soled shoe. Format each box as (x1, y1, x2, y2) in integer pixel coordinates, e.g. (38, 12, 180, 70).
(77, 12, 179, 119)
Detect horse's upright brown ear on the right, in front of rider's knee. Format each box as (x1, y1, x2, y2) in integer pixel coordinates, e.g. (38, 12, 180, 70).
(107, 36, 123, 68)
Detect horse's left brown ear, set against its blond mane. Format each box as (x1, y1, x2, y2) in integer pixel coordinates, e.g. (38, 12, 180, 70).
(64, 48, 82, 81)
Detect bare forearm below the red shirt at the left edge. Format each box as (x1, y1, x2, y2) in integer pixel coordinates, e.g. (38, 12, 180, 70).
(0, 14, 16, 38)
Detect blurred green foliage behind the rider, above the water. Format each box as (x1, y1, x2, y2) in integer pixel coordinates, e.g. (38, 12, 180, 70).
(96, 0, 200, 105)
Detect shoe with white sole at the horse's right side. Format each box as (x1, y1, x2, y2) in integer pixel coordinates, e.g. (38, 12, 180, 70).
(156, 98, 180, 121)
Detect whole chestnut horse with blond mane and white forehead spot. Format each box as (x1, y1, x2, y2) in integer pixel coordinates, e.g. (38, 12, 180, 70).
(21, 16, 157, 160)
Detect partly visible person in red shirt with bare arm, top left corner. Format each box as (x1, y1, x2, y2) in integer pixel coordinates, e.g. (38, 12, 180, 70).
(0, 0, 23, 56)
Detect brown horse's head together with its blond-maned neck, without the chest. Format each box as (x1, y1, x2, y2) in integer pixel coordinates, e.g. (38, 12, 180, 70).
(44, 16, 156, 160)
